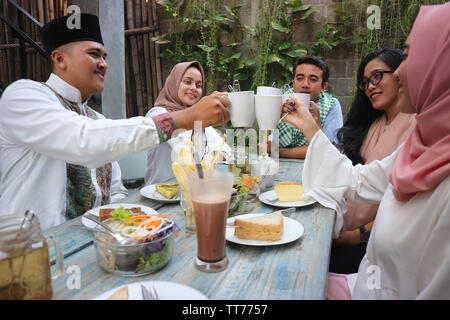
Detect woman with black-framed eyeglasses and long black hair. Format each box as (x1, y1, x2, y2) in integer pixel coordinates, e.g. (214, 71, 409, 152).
(329, 48, 415, 274)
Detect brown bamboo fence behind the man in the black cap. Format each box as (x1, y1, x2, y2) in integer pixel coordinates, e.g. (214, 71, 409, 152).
(0, 0, 162, 117)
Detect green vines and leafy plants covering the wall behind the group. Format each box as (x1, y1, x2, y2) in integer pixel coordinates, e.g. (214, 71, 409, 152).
(156, 0, 446, 94)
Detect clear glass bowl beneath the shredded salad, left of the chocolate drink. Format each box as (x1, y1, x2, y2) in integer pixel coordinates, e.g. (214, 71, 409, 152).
(94, 228, 175, 276)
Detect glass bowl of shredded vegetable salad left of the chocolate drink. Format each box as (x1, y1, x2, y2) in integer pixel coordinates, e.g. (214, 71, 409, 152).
(94, 207, 178, 276)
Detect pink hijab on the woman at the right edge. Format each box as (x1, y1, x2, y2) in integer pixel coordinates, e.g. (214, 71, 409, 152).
(389, 3, 450, 201)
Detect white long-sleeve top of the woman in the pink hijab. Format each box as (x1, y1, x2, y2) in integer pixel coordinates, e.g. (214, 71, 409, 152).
(302, 131, 450, 299)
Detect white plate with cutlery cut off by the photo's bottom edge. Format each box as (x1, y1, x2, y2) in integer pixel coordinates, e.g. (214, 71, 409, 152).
(93, 281, 208, 300)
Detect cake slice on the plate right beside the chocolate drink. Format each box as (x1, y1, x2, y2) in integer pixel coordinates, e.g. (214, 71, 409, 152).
(234, 212, 284, 241)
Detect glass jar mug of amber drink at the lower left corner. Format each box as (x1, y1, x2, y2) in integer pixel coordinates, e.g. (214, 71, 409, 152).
(0, 214, 63, 300)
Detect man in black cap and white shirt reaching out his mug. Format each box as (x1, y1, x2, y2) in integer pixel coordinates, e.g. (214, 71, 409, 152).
(0, 14, 229, 229)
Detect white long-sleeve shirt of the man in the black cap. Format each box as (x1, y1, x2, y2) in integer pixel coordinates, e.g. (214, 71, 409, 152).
(0, 74, 166, 229)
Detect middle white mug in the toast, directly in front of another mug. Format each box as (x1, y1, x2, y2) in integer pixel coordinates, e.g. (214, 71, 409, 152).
(255, 95, 283, 130)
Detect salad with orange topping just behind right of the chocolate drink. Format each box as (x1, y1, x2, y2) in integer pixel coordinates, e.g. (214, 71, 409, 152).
(228, 174, 259, 216)
